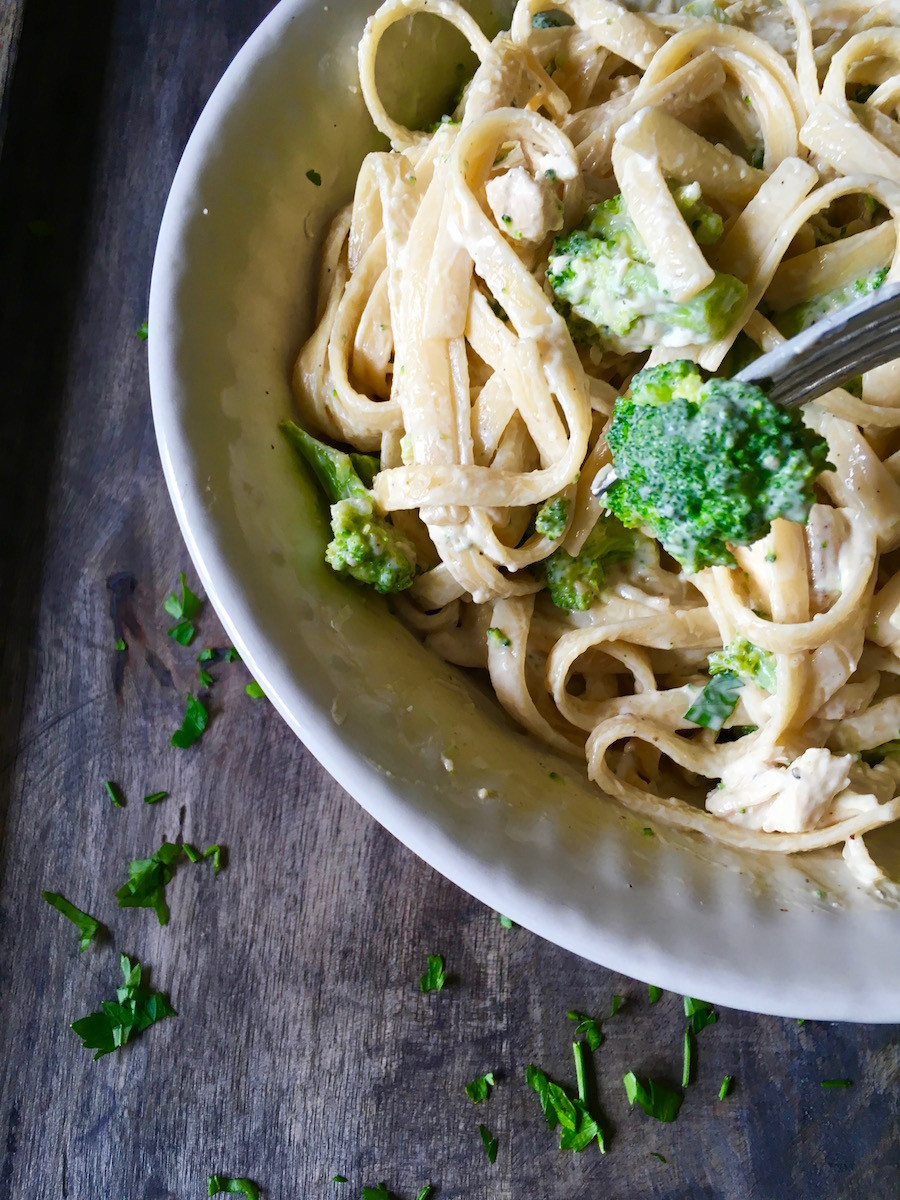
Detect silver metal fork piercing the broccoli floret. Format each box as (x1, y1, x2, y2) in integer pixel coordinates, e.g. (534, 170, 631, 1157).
(590, 283, 900, 496)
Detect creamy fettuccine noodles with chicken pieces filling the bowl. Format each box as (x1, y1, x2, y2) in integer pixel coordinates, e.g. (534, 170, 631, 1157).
(294, 0, 900, 886)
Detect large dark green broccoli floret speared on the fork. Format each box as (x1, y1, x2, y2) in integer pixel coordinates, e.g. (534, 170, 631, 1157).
(606, 361, 830, 571)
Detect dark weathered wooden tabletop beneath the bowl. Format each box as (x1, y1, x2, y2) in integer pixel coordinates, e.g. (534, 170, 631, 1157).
(0, 0, 900, 1200)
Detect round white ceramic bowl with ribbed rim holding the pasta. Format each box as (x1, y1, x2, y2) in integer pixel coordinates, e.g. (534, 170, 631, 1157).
(149, 0, 900, 1021)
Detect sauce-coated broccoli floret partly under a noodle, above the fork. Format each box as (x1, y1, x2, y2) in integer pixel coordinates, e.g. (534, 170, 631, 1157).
(547, 184, 746, 353)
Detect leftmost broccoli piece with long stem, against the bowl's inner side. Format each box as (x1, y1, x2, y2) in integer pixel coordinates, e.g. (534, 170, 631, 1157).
(281, 421, 415, 592)
